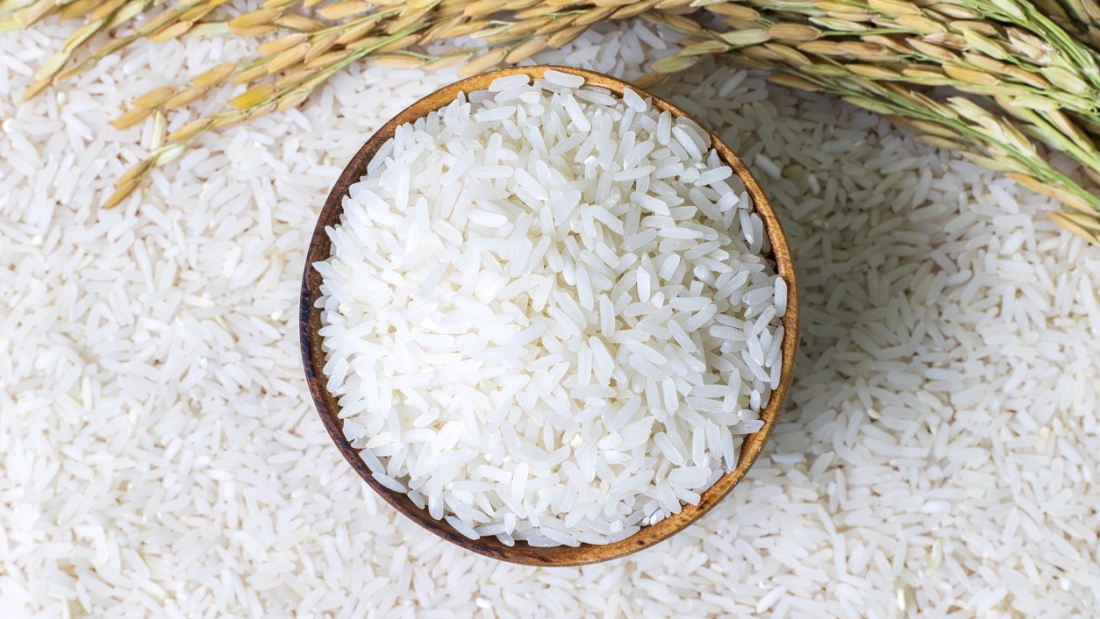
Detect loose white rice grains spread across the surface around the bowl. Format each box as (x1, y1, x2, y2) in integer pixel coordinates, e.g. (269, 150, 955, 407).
(0, 9, 1100, 619)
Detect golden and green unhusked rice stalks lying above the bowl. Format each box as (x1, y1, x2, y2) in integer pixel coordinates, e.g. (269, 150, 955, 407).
(8, 0, 1100, 237)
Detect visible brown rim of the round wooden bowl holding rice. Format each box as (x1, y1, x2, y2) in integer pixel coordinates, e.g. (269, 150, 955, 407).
(298, 66, 799, 566)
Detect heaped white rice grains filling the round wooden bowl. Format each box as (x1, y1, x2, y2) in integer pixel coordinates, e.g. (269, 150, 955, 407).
(315, 70, 787, 546)
